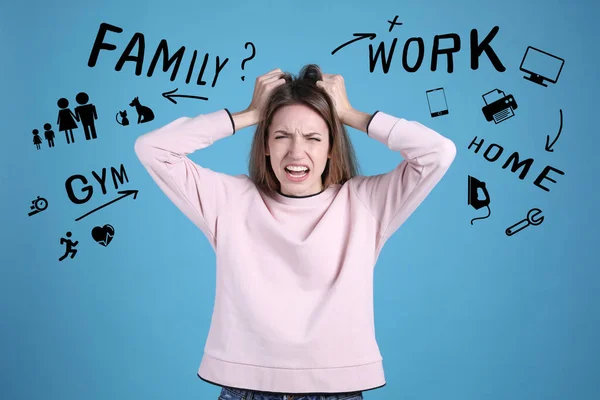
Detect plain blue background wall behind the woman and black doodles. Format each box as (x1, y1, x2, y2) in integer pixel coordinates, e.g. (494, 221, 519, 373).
(0, 0, 600, 400)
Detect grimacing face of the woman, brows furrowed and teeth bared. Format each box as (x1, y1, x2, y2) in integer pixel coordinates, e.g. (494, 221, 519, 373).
(266, 104, 331, 196)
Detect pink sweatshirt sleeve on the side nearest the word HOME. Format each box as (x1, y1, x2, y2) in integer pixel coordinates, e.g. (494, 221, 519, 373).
(350, 111, 456, 247)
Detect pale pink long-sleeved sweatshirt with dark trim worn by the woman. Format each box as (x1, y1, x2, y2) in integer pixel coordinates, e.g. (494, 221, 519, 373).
(135, 109, 456, 393)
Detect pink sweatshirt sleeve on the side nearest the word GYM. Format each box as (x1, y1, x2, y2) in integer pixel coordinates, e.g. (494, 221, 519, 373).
(134, 109, 243, 250)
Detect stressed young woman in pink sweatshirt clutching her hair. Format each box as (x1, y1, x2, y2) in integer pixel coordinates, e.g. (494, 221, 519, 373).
(135, 64, 456, 400)
